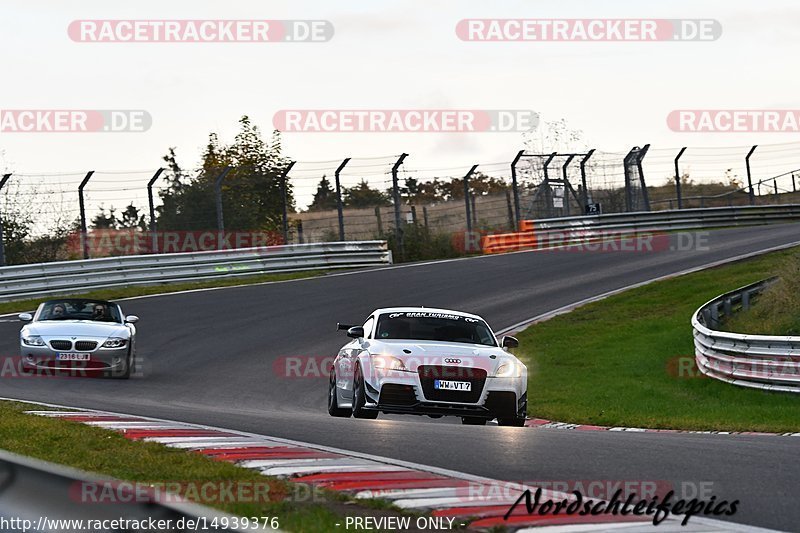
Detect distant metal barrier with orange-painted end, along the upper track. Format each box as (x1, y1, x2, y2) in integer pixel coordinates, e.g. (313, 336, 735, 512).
(481, 204, 800, 254)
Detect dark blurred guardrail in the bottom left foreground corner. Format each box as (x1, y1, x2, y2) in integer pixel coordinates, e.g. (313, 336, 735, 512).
(0, 450, 243, 532)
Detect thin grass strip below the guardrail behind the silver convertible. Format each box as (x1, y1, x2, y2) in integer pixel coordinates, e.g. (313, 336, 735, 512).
(0, 270, 326, 314)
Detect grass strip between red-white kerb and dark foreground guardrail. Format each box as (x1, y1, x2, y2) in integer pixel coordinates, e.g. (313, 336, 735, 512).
(0, 401, 424, 532)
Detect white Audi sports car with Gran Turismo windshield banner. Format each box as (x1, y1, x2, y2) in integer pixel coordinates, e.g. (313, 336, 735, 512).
(328, 307, 528, 426)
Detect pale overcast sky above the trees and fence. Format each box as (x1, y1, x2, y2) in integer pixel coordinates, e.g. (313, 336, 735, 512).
(0, 0, 800, 210)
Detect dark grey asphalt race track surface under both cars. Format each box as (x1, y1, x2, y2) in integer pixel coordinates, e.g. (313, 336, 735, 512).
(0, 224, 800, 530)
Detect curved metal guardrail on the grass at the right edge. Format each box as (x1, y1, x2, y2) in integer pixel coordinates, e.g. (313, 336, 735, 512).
(692, 278, 800, 393)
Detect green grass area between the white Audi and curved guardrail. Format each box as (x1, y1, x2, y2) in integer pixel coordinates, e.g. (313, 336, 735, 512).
(517, 249, 800, 432)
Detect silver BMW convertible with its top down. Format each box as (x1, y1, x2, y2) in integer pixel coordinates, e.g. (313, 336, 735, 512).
(19, 298, 139, 379)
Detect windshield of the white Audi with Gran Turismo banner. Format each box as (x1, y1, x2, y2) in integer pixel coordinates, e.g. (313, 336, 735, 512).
(375, 311, 497, 346)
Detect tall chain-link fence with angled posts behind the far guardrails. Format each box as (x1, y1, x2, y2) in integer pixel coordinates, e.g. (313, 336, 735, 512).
(0, 143, 800, 264)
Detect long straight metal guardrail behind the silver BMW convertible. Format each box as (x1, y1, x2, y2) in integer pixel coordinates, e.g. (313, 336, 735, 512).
(0, 241, 392, 301)
